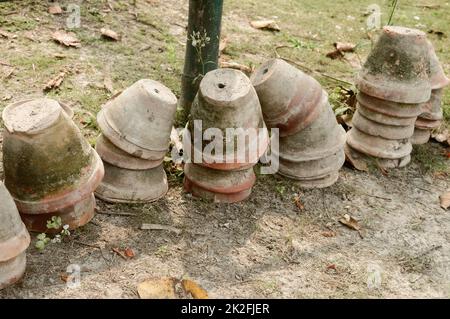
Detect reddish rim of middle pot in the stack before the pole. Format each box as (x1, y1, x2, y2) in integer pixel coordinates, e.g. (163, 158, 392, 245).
(184, 163, 256, 194)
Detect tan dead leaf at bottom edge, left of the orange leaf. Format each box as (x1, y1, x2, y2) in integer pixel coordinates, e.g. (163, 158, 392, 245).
(137, 277, 177, 299)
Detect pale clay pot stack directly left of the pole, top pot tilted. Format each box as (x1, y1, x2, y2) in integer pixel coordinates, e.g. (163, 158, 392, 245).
(95, 79, 177, 203)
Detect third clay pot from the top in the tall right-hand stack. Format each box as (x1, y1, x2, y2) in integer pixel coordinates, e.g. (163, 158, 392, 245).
(352, 110, 414, 140)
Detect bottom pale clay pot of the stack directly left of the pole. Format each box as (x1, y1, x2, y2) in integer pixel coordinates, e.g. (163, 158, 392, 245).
(95, 163, 169, 203)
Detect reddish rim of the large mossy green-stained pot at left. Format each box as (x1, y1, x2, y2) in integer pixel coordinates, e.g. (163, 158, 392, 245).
(14, 148, 105, 215)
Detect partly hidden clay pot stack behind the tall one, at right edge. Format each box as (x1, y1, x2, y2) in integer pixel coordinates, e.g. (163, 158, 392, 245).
(412, 41, 450, 144)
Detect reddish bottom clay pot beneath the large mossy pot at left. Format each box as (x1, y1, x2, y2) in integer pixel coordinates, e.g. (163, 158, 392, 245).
(20, 194, 96, 234)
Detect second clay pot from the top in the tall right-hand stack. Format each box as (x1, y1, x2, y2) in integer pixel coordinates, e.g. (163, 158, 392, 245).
(356, 92, 423, 126)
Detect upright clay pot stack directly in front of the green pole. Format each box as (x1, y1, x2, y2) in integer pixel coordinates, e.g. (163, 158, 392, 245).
(183, 69, 269, 203)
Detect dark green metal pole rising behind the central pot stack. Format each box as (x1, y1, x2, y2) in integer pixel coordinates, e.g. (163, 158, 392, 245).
(180, 0, 223, 119)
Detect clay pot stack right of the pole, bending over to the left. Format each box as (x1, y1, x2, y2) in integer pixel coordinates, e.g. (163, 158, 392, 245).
(251, 59, 345, 188)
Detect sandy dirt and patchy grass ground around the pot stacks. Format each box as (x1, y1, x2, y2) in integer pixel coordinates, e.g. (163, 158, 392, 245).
(0, 0, 450, 298)
